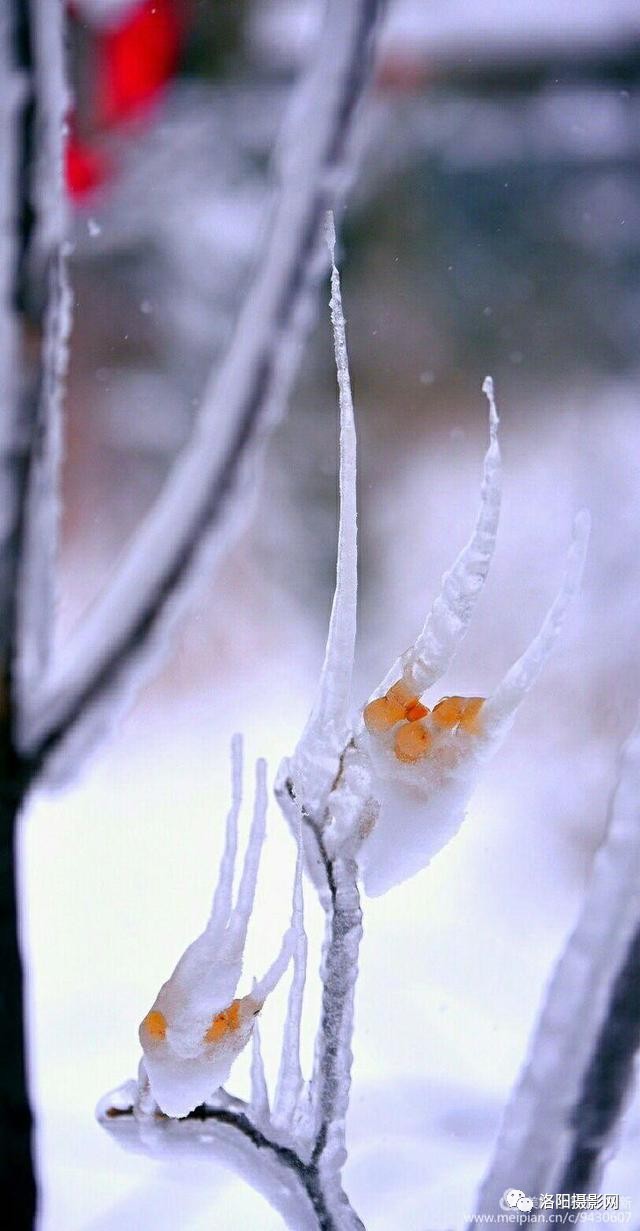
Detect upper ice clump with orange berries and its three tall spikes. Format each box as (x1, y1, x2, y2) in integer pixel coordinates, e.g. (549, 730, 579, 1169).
(277, 225, 590, 895)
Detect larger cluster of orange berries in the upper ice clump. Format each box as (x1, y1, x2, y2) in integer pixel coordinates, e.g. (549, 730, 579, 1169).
(363, 680, 485, 764)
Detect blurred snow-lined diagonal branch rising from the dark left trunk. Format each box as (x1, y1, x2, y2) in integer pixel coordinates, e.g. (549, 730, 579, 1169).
(20, 0, 382, 764)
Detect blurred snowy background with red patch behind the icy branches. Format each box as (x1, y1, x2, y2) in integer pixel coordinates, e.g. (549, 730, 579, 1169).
(22, 0, 640, 1231)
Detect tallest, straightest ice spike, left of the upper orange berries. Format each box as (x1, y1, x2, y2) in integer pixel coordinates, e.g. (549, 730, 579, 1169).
(289, 213, 358, 803)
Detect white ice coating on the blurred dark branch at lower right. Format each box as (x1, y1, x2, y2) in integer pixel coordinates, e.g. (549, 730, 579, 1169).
(473, 720, 640, 1225)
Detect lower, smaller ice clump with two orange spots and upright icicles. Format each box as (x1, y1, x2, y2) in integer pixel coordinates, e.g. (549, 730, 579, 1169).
(139, 736, 299, 1117)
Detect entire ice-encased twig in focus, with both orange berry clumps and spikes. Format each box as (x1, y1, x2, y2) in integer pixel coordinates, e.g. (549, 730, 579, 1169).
(98, 222, 593, 1231)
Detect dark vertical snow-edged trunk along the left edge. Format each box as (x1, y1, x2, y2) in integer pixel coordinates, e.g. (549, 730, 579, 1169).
(0, 0, 67, 1231)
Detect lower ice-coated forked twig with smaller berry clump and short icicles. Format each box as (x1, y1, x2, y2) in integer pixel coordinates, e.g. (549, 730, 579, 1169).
(97, 737, 362, 1231)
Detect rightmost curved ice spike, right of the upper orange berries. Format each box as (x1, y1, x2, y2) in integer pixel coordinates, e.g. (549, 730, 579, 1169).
(482, 508, 591, 735)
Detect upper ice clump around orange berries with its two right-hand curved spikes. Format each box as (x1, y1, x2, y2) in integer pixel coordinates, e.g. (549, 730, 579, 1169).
(349, 408, 590, 895)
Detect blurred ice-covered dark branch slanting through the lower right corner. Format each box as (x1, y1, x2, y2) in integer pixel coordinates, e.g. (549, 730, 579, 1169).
(478, 721, 640, 1214)
